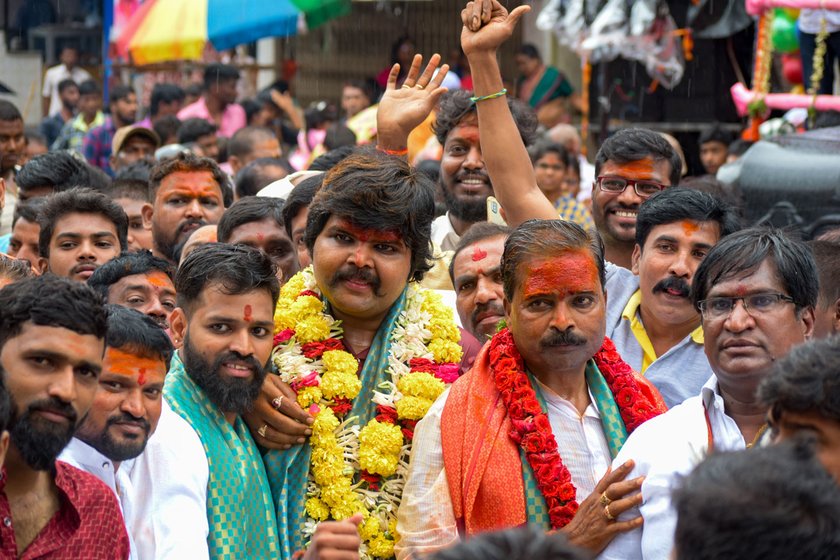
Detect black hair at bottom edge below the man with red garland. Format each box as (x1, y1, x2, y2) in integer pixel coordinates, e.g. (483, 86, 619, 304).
(427, 525, 591, 560)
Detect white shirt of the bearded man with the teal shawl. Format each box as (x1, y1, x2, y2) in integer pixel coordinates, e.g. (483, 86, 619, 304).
(128, 400, 210, 560)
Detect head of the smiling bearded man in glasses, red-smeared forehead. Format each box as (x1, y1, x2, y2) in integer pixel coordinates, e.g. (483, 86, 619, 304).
(592, 128, 682, 269)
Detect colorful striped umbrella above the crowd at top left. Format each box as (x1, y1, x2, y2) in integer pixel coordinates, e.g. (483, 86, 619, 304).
(116, 0, 350, 65)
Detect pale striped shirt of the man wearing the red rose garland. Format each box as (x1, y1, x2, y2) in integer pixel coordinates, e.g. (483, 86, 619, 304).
(395, 384, 610, 560)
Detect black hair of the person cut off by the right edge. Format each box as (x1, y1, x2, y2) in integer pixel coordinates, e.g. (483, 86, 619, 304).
(758, 336, 840, 423)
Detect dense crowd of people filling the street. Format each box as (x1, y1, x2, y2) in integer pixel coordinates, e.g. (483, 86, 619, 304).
(0, 0, 840, 560)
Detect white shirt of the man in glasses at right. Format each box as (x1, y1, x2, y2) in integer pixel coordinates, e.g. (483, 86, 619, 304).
(598, 377, 747, 560)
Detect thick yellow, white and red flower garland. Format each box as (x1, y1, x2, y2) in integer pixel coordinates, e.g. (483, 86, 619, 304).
(272, 267, 461, 559)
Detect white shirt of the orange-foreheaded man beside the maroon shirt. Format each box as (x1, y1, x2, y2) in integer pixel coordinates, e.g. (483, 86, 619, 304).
(58, 438, 143, 560)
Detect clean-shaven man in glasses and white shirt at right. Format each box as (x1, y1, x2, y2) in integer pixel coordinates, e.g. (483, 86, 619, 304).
(599, 228, 818, 560)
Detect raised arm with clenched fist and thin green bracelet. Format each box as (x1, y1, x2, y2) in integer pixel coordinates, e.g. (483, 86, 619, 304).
(461, 0, 557, 223)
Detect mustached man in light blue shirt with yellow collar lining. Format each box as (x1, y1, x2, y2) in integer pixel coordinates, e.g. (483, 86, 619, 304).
(607, 187, 740, 407)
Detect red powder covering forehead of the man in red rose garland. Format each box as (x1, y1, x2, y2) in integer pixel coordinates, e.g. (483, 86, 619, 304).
(523, 250, 600, 299)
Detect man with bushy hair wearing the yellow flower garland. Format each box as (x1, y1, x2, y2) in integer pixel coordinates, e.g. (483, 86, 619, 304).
(252, 57, 477, 558)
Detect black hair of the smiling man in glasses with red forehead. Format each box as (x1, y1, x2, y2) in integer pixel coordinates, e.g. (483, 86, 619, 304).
(595, 128, 682, 187)
